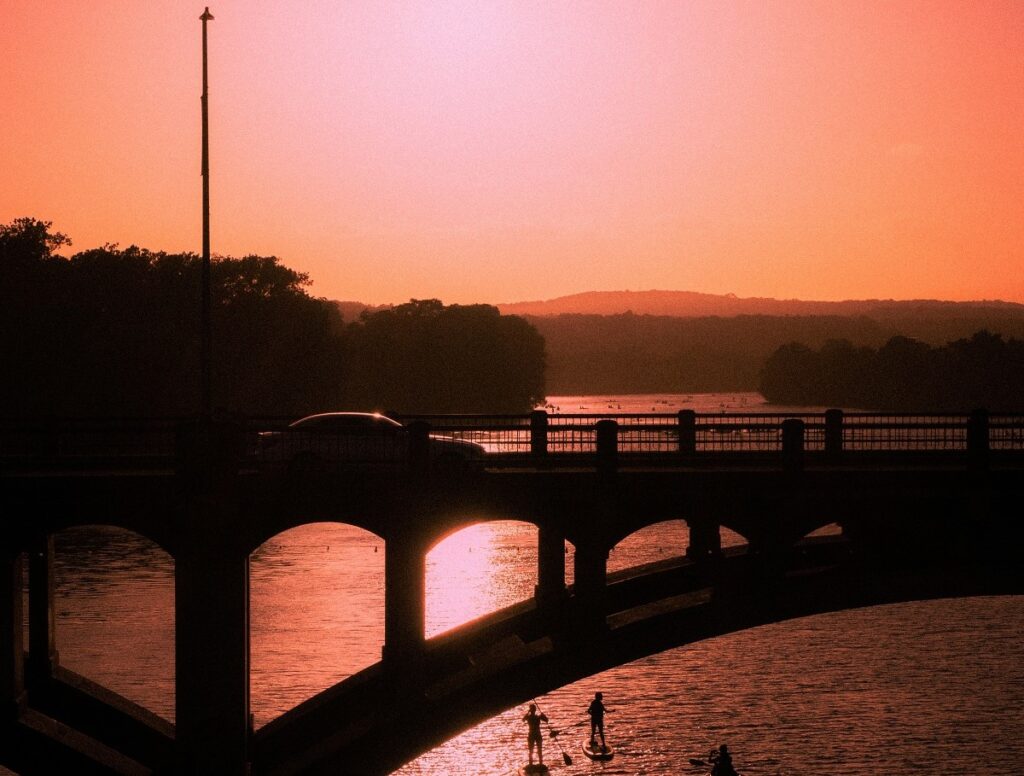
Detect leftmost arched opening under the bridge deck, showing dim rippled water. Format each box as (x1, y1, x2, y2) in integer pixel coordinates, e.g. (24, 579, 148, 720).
(34, 521, 176, 724)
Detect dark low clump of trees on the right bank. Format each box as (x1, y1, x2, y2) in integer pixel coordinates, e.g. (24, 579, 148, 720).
(760, 330, 1024, 412)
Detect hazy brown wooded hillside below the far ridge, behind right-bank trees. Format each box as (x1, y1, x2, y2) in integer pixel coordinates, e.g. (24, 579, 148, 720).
(526, 311, 1024, 395)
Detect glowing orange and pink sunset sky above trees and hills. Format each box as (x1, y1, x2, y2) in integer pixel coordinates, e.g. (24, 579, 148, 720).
(0, 0, 1024, 303)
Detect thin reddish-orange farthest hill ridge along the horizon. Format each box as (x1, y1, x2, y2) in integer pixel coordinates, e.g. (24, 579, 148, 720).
(496, 291, 1024, 317)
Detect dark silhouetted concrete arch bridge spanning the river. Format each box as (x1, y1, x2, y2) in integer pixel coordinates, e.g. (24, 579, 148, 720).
(0, 412, 1024, 774)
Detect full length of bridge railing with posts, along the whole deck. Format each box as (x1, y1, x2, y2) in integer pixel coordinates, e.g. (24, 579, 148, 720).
(0, 409, 1024, 467)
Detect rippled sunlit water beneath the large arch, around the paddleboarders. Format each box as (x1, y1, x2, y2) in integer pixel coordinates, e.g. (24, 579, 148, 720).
(398, 598, 1024, 776)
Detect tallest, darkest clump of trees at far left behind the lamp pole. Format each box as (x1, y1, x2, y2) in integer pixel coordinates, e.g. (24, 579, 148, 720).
(0, 218, 344, 417)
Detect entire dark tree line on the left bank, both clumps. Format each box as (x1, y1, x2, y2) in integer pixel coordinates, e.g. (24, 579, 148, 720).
(0, 218, 545, 418)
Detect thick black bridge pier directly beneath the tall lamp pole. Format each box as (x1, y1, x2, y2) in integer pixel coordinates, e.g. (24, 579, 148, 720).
(174, 423, 250, 776)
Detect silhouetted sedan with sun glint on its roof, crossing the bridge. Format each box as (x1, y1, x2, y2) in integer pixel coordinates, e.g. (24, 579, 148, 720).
(256, 413, 485, 471)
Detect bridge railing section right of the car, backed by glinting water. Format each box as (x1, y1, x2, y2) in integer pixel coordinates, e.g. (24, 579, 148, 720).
(391, 409, 1024, 468)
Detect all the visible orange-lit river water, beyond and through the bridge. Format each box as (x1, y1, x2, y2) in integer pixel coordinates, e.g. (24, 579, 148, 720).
(36, 393, 1024, 776)
